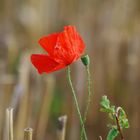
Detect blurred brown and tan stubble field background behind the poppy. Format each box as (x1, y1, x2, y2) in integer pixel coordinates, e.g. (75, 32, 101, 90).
(0, 0, 140, 140)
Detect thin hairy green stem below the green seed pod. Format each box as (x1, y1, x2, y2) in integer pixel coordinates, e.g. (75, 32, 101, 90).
(81, 65, 91, 140)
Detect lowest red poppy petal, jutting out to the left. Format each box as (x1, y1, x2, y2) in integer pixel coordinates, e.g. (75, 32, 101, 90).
(31, 54, 65, 74)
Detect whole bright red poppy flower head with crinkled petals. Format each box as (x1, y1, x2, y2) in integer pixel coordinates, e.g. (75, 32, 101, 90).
(31, 26, 85, 74)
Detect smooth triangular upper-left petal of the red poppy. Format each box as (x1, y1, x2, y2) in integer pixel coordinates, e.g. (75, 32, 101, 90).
(38, 33, 59, 55)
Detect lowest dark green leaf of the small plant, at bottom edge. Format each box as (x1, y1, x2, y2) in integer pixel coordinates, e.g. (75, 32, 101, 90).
(107, 128, 119, 140)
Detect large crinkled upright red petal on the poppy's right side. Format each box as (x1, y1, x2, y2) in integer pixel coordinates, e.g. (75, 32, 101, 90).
(54, 26, 85, 65)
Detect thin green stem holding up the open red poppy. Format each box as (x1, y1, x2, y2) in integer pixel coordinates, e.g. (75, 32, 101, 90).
(67, 66, 88, 140)
